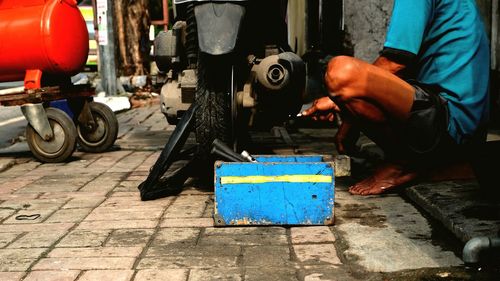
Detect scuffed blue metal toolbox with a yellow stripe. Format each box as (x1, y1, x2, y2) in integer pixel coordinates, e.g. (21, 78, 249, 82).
(214, 156, 335, 226)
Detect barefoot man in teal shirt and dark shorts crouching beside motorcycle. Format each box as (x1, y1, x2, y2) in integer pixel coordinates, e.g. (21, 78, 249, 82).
(302, 0, 489, 195)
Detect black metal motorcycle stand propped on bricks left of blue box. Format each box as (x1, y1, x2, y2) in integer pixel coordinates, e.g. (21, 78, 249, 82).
(138, 102, 198, 201)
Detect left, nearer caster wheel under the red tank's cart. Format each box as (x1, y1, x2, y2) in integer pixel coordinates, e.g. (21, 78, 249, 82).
(26, 108, 76, 163)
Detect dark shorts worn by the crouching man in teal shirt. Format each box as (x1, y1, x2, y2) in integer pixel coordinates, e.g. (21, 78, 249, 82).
(403, 81, 455, 158)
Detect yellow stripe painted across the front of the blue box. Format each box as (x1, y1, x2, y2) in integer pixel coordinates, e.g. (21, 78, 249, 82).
(220, 175, 333, 184)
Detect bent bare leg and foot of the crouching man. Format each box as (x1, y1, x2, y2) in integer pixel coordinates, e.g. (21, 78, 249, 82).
(325, 57, 417, 195)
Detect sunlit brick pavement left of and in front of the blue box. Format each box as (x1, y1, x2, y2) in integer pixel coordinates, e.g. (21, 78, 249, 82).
(0, 105, 350, 281)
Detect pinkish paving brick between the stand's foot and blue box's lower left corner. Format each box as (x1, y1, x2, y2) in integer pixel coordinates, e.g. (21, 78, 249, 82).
(164, 195, 210, 218)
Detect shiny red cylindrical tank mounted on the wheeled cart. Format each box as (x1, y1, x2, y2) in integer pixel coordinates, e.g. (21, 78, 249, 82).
(0, 0, 89, 82)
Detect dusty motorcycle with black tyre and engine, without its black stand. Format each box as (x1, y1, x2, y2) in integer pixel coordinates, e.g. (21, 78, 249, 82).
(154, 0, 306, 159)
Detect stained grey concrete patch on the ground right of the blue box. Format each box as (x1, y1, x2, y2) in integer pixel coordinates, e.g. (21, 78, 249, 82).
(335, 184, 462, 272)
